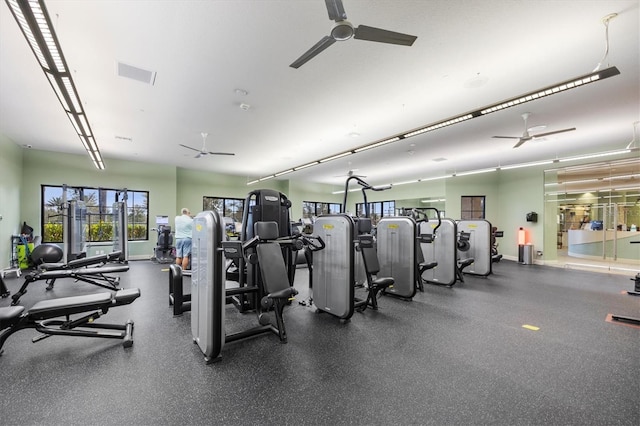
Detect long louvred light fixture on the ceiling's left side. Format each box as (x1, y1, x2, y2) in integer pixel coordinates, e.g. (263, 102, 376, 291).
(6, 0, 105, 170)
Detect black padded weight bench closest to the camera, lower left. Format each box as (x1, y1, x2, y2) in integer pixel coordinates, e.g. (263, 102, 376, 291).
(0, 288, 140, 355)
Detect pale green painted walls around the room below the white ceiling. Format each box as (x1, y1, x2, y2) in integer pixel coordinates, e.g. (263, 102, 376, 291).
(6, 146, 636, 267)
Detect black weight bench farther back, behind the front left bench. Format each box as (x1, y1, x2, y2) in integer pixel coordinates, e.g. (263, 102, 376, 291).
(11, 252, 129, 305)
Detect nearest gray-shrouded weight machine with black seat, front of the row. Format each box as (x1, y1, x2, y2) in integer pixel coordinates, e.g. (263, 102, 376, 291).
(191, 211, 297, 363)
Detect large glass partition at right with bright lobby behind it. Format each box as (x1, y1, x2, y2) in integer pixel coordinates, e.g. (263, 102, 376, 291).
(544, 159, 640, 271)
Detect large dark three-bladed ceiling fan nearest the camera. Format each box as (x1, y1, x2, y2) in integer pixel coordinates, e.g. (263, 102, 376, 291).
(289, 0, 418, 68)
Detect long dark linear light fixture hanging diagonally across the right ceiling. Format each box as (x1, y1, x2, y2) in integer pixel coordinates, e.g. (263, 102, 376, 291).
(246, 65, 628, 185)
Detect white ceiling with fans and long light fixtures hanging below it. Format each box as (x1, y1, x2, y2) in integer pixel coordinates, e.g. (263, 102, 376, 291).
(0, 0, 640, 190)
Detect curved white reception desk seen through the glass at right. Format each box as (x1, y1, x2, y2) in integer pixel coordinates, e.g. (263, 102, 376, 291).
(567, 229, 640, 260)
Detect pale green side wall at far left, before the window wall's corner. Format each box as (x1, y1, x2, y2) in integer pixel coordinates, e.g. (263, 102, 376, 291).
(0, 135, 23, 269)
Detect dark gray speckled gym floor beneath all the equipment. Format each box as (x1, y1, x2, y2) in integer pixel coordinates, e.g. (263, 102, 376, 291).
(0, 261, 640, 425)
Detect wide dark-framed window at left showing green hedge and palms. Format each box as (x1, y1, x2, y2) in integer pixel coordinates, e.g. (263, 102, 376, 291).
(41, 185, 149, 243)
